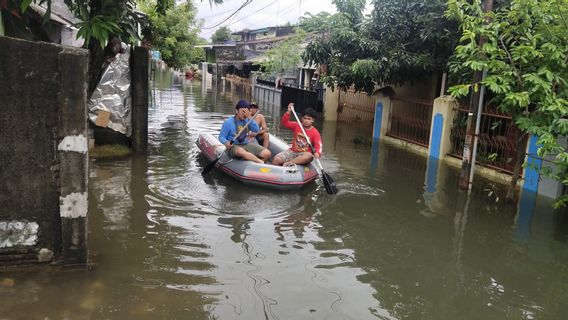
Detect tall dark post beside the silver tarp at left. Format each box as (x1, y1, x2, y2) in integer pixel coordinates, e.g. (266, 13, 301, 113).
(130, 47, 149, 153)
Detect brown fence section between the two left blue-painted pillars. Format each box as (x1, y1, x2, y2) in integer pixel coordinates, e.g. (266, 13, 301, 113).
(387, 97, 433, 147)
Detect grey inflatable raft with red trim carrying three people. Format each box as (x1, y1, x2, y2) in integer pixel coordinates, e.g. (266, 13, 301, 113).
(195, 133, 319, 190)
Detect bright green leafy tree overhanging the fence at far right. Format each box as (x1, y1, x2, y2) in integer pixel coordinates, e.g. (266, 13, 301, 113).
(447, 0, 568, 206)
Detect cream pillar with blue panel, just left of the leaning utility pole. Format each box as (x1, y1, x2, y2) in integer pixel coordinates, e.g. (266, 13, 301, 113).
(428, 96, 456, 159)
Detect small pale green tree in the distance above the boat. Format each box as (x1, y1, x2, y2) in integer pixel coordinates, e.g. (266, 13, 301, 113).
(261, 29, 306, 76)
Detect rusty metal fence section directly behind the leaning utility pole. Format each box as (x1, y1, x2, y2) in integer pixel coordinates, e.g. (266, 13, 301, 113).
(449, 106, 521, 173)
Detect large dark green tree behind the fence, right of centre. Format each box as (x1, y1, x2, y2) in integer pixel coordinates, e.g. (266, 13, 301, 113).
(304, 0, 457, 92)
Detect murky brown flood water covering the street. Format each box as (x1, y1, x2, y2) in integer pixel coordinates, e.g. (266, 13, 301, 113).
(0, 70, 568, 319)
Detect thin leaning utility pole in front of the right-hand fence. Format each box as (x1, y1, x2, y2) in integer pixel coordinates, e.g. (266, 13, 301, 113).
(459, 0, 493, 190)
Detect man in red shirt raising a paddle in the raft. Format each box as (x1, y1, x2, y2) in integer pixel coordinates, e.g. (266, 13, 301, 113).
(272, 103, 323, 166)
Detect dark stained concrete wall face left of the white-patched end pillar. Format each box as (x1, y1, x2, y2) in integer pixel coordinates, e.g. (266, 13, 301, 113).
(0, 37, 63, 266)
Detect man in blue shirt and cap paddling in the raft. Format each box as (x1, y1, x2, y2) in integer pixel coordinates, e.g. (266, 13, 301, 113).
(219, 100, 272, 163)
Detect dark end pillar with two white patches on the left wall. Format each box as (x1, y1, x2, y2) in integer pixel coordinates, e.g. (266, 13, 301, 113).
(57, 48, 89, 264)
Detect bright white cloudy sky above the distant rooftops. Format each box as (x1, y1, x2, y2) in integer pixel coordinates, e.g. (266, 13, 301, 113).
(195, 0, 370, 40)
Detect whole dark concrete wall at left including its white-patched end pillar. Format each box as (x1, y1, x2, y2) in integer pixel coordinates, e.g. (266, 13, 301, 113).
(0, 37, 88, 266)
